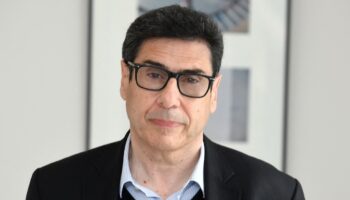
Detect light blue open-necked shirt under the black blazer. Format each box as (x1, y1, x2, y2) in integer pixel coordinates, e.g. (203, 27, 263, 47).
(119, 135, 204, 200)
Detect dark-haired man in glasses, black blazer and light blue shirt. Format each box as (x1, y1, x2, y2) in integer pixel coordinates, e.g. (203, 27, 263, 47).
(27, 6, 304, 200)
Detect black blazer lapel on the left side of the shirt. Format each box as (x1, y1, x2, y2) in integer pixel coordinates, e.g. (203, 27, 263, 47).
(84, 133, 129, 200)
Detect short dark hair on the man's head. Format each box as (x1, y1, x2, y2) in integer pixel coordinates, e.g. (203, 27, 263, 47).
(122, 5, 223, 76)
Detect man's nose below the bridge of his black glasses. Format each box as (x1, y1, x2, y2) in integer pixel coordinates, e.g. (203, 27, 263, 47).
(157, 78, 181, 109)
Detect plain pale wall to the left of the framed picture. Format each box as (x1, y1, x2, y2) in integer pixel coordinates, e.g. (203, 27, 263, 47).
(0, 0, 87, 200)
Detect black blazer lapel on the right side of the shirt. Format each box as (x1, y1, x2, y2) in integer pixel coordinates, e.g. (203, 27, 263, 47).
(204, 137, 242, 200)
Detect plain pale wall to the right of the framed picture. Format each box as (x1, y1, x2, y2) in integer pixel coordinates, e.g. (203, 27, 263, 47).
(287, 0, 350, 200)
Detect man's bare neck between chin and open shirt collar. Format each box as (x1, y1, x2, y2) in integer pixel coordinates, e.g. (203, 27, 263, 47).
(129, 131, 203, 199)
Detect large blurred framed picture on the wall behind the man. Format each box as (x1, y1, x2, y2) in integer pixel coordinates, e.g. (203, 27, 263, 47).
(88, 0, 288, 169)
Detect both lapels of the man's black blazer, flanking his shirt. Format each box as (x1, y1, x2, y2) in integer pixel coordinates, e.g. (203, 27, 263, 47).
(84, 131, 242, 200)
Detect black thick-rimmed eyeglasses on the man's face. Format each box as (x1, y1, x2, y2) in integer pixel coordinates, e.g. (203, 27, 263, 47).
(125, 61, 215, 98)
